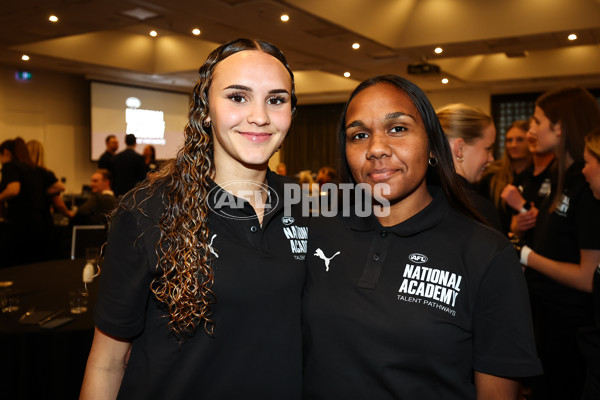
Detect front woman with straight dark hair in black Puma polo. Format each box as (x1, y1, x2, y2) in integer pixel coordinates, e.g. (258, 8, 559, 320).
(303, 75, 541, 400)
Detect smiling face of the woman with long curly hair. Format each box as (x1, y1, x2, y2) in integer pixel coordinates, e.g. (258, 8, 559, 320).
(206, 50, 292, 173)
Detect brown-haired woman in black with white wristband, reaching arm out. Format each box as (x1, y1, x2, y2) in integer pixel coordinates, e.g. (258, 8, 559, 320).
(521, 86, 600, 399)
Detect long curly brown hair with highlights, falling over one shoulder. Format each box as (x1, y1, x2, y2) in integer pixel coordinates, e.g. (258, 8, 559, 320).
(136, 39, 296, 336)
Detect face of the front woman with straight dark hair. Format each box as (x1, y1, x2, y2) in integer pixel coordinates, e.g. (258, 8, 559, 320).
(345, 83, 430, 215)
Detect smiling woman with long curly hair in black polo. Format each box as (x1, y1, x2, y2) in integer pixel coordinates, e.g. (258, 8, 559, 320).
(81, 39, 307, 399)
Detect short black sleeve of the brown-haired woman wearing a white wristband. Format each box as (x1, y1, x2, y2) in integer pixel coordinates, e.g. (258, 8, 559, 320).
(574, 187, 600, 250)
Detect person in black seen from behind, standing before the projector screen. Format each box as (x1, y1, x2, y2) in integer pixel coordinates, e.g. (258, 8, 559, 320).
(112, 133, 148, 197)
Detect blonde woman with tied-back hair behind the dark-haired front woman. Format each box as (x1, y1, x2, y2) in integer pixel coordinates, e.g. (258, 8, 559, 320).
(437, 104, 502, 232)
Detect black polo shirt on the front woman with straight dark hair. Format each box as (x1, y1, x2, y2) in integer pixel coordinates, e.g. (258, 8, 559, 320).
(303, 188, 541, 400)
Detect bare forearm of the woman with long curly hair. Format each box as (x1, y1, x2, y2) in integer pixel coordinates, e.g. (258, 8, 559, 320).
(79, 328, 131, 400)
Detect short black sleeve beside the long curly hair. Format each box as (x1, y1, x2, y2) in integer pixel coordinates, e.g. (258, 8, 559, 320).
(94, 210, 153, 338)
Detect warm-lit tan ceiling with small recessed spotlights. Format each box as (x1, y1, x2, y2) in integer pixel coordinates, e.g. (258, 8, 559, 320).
(0, 0, 600, 103)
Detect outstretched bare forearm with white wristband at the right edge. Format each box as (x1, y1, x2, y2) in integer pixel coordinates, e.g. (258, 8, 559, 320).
(521, 247, 600, 292)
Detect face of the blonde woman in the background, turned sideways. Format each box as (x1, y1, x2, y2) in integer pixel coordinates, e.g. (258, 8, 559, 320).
(455, 124, 496, 183)
